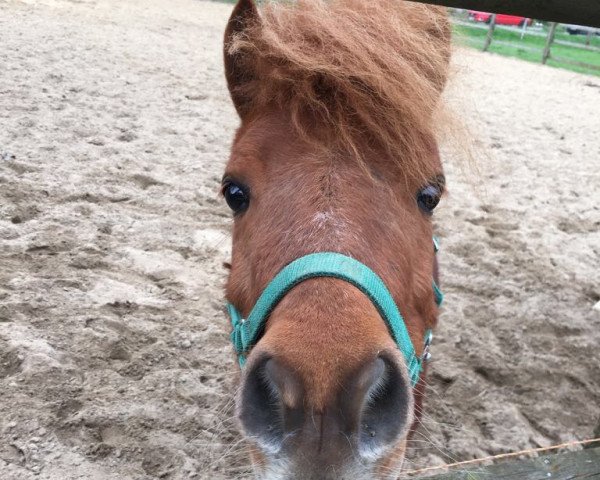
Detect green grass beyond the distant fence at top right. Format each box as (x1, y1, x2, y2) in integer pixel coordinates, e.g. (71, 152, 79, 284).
(454, 24, 600, 76)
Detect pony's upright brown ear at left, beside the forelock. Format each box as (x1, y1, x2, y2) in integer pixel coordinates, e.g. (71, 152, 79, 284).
(223, 0, 260, 118)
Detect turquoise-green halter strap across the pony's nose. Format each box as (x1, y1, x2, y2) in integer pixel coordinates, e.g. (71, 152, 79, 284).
(227, 237, 444, 387)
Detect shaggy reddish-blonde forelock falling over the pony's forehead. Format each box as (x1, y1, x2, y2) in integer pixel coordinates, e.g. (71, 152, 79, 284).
(229, 0, 450, 179)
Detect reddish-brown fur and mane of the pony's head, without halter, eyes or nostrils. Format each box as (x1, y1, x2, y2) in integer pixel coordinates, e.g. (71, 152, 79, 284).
(225, 0, 450, 478)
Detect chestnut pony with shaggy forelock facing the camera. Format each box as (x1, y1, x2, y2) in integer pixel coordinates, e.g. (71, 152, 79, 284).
(222, 0, 450, 480)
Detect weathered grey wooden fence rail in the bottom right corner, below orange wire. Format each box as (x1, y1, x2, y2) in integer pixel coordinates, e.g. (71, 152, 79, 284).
(412, 448, 600, 480)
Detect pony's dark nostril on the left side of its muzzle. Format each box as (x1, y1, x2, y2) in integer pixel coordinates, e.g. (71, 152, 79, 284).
(238, 356, 302, 451)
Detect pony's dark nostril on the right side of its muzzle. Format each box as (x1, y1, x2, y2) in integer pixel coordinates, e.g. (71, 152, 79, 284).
(347, 356, 412, 457)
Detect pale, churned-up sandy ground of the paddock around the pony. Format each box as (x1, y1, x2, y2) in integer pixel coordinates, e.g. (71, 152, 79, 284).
(0, 0, 600, 480)
